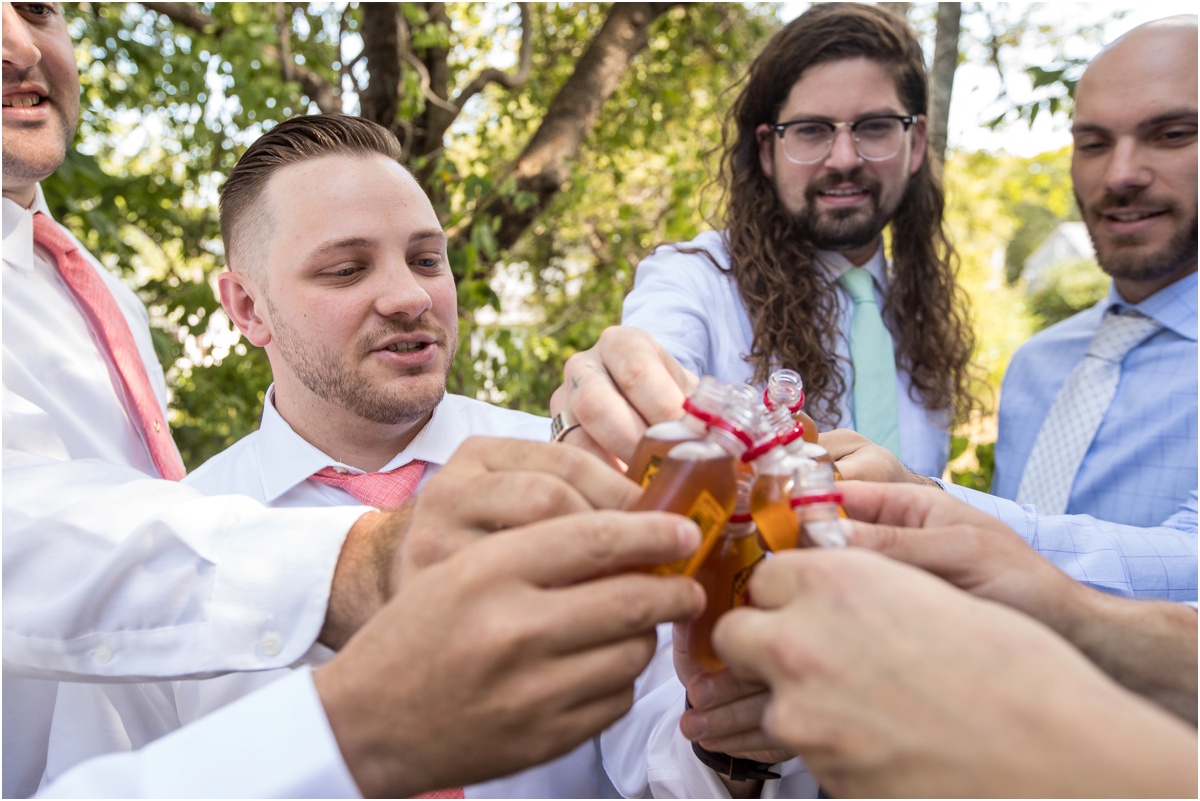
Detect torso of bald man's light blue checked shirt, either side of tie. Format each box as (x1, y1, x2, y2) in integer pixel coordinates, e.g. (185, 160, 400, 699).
(991, 273, 1198, 526)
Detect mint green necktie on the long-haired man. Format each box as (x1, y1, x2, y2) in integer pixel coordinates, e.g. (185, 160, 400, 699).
(838, 267, 900, 457)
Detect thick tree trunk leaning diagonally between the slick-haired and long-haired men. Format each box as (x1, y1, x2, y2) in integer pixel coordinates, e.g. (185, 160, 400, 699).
(454, 2, 676, 257)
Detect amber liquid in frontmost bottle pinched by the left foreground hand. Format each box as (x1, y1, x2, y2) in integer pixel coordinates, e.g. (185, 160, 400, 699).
(634, 440, 738, 576)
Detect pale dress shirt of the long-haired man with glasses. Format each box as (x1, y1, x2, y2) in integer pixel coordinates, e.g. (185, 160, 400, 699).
(622, 231, 950, 476)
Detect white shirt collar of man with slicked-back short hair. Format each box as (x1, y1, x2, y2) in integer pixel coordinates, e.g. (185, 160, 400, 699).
(254, 384, 463, 504)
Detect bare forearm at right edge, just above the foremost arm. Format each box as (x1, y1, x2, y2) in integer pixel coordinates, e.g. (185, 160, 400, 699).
(1062, 590, 1196, 725)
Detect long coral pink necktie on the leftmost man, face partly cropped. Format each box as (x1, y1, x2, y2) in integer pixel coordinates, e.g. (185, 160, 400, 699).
(34, 212, 187, 481)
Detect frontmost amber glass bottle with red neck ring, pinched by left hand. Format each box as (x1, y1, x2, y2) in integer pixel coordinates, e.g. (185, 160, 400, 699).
(634, 397, 757, 576)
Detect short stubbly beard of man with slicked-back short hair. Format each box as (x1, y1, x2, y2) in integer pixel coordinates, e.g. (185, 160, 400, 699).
(269, 305, 457, 426)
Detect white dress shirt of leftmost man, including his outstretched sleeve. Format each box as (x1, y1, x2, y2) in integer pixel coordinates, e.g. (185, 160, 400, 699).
(4, 188, 360, 796)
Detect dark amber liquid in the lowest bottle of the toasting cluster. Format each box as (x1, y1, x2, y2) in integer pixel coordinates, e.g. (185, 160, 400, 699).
(686, 523, 764, 670)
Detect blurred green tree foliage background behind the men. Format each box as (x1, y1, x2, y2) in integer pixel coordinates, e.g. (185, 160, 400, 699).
(43, 2, 1108, 489)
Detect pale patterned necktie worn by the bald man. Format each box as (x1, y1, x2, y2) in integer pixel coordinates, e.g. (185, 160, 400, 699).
(1016, 307, 1160, 514)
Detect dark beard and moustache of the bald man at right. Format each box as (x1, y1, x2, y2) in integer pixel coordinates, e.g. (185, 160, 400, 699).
(1075, 189, 1196, 282)
